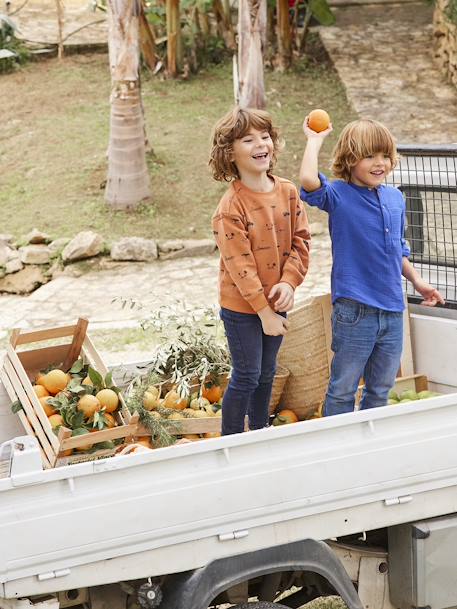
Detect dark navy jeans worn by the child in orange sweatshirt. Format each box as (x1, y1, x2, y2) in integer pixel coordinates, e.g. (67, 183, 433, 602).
(220, 308, 285, 436)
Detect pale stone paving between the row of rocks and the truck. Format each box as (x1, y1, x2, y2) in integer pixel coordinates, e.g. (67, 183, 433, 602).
(0, 236, 331, 362)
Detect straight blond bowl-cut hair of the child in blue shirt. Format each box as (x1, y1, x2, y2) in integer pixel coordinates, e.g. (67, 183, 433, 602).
(332, 118, 398, 182)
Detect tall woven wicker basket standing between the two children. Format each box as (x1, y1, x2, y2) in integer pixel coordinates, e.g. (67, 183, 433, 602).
(278, 295, 332, 420)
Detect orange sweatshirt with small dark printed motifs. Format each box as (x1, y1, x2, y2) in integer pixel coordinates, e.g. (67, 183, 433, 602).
(212, 176, 310, 313)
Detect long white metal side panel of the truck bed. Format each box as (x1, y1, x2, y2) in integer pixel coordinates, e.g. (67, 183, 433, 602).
(0, 394, 457, 598)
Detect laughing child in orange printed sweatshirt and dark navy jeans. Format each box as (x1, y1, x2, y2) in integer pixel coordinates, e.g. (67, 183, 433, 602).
(209, 107, 310, 435)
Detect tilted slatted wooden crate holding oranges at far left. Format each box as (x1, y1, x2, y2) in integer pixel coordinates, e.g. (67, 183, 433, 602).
(0, 319, 138, 468)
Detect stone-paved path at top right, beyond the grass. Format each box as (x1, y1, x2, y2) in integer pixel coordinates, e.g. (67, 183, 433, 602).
(320, 2, 457, 144)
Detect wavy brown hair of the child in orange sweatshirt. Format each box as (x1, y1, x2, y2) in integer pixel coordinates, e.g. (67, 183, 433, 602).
(208, 106, 282, 182)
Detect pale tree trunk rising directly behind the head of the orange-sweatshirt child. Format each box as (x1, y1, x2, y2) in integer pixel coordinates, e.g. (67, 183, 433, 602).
(238, 0, 267, 108)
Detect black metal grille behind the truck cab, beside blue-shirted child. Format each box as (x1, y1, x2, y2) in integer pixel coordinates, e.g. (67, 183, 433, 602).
(388, 145, 457, 308)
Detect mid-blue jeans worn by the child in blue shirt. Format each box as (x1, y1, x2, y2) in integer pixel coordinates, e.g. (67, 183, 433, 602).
(324, 298, 403, 416)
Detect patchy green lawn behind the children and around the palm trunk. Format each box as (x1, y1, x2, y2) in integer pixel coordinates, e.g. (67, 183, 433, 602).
(0, 42, 355, 242)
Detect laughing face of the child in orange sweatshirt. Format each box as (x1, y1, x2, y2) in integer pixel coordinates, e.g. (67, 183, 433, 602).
(233, 127, 274, 179)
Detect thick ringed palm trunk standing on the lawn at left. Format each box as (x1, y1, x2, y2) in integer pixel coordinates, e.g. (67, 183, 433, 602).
(105, 0, 151, 210)
